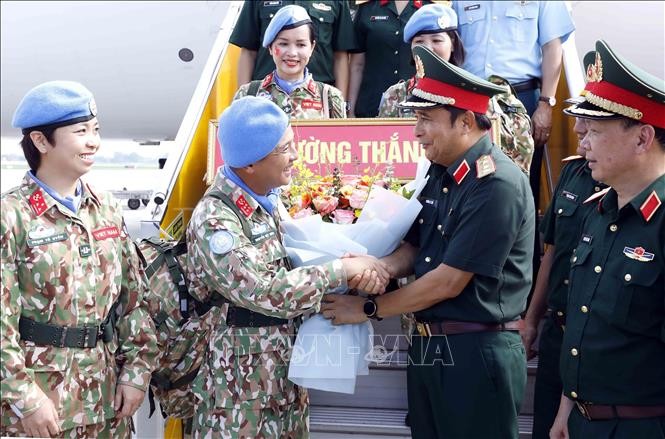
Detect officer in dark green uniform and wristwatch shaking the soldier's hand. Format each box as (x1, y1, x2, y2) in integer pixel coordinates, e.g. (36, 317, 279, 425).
(322, 46, 535, 439)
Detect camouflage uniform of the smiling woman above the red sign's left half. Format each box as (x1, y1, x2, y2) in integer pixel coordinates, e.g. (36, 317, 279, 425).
(233, 72, 346, 119)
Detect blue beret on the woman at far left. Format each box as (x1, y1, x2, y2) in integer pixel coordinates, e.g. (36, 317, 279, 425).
(12, 81, 97, 134)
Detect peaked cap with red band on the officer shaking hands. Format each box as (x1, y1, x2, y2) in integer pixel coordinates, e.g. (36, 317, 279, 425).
(399, 46, 507, 114)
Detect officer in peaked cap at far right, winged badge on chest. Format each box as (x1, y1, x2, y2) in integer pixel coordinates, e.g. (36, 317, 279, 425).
(550, 41, 665, 438)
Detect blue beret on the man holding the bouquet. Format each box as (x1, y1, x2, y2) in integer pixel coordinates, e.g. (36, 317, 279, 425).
(217, 96, 289, 168)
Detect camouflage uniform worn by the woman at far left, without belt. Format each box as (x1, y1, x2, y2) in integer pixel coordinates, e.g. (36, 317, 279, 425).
(0, 175, 157, 437)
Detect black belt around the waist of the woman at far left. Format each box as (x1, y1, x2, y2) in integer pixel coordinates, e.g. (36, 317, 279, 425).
(18, 316, 115, 348)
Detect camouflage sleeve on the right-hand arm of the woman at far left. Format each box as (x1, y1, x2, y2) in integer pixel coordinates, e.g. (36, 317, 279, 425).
(111, 196, 158, 391)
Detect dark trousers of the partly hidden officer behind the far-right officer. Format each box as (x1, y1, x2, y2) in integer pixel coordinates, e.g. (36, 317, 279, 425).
(532, 316, 563, 439)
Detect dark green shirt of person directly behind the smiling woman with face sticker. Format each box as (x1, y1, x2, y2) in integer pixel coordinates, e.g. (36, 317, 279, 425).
(229, 0, 358, 85)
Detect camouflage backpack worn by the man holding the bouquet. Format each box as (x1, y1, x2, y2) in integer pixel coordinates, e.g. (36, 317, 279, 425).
(138, 191, 251, 419)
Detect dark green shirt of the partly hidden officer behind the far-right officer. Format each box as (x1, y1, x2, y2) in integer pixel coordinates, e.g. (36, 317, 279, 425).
(540, 156, 605, 312)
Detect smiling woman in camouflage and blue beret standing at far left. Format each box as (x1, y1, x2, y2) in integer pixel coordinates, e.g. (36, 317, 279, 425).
(0, 81, 157, 438)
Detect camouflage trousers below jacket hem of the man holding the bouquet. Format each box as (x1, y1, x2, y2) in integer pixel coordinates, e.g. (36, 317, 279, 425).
(192, 389, 309, 439)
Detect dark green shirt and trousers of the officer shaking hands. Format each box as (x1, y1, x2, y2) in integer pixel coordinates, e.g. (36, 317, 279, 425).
(406, 135, 534, 439)
